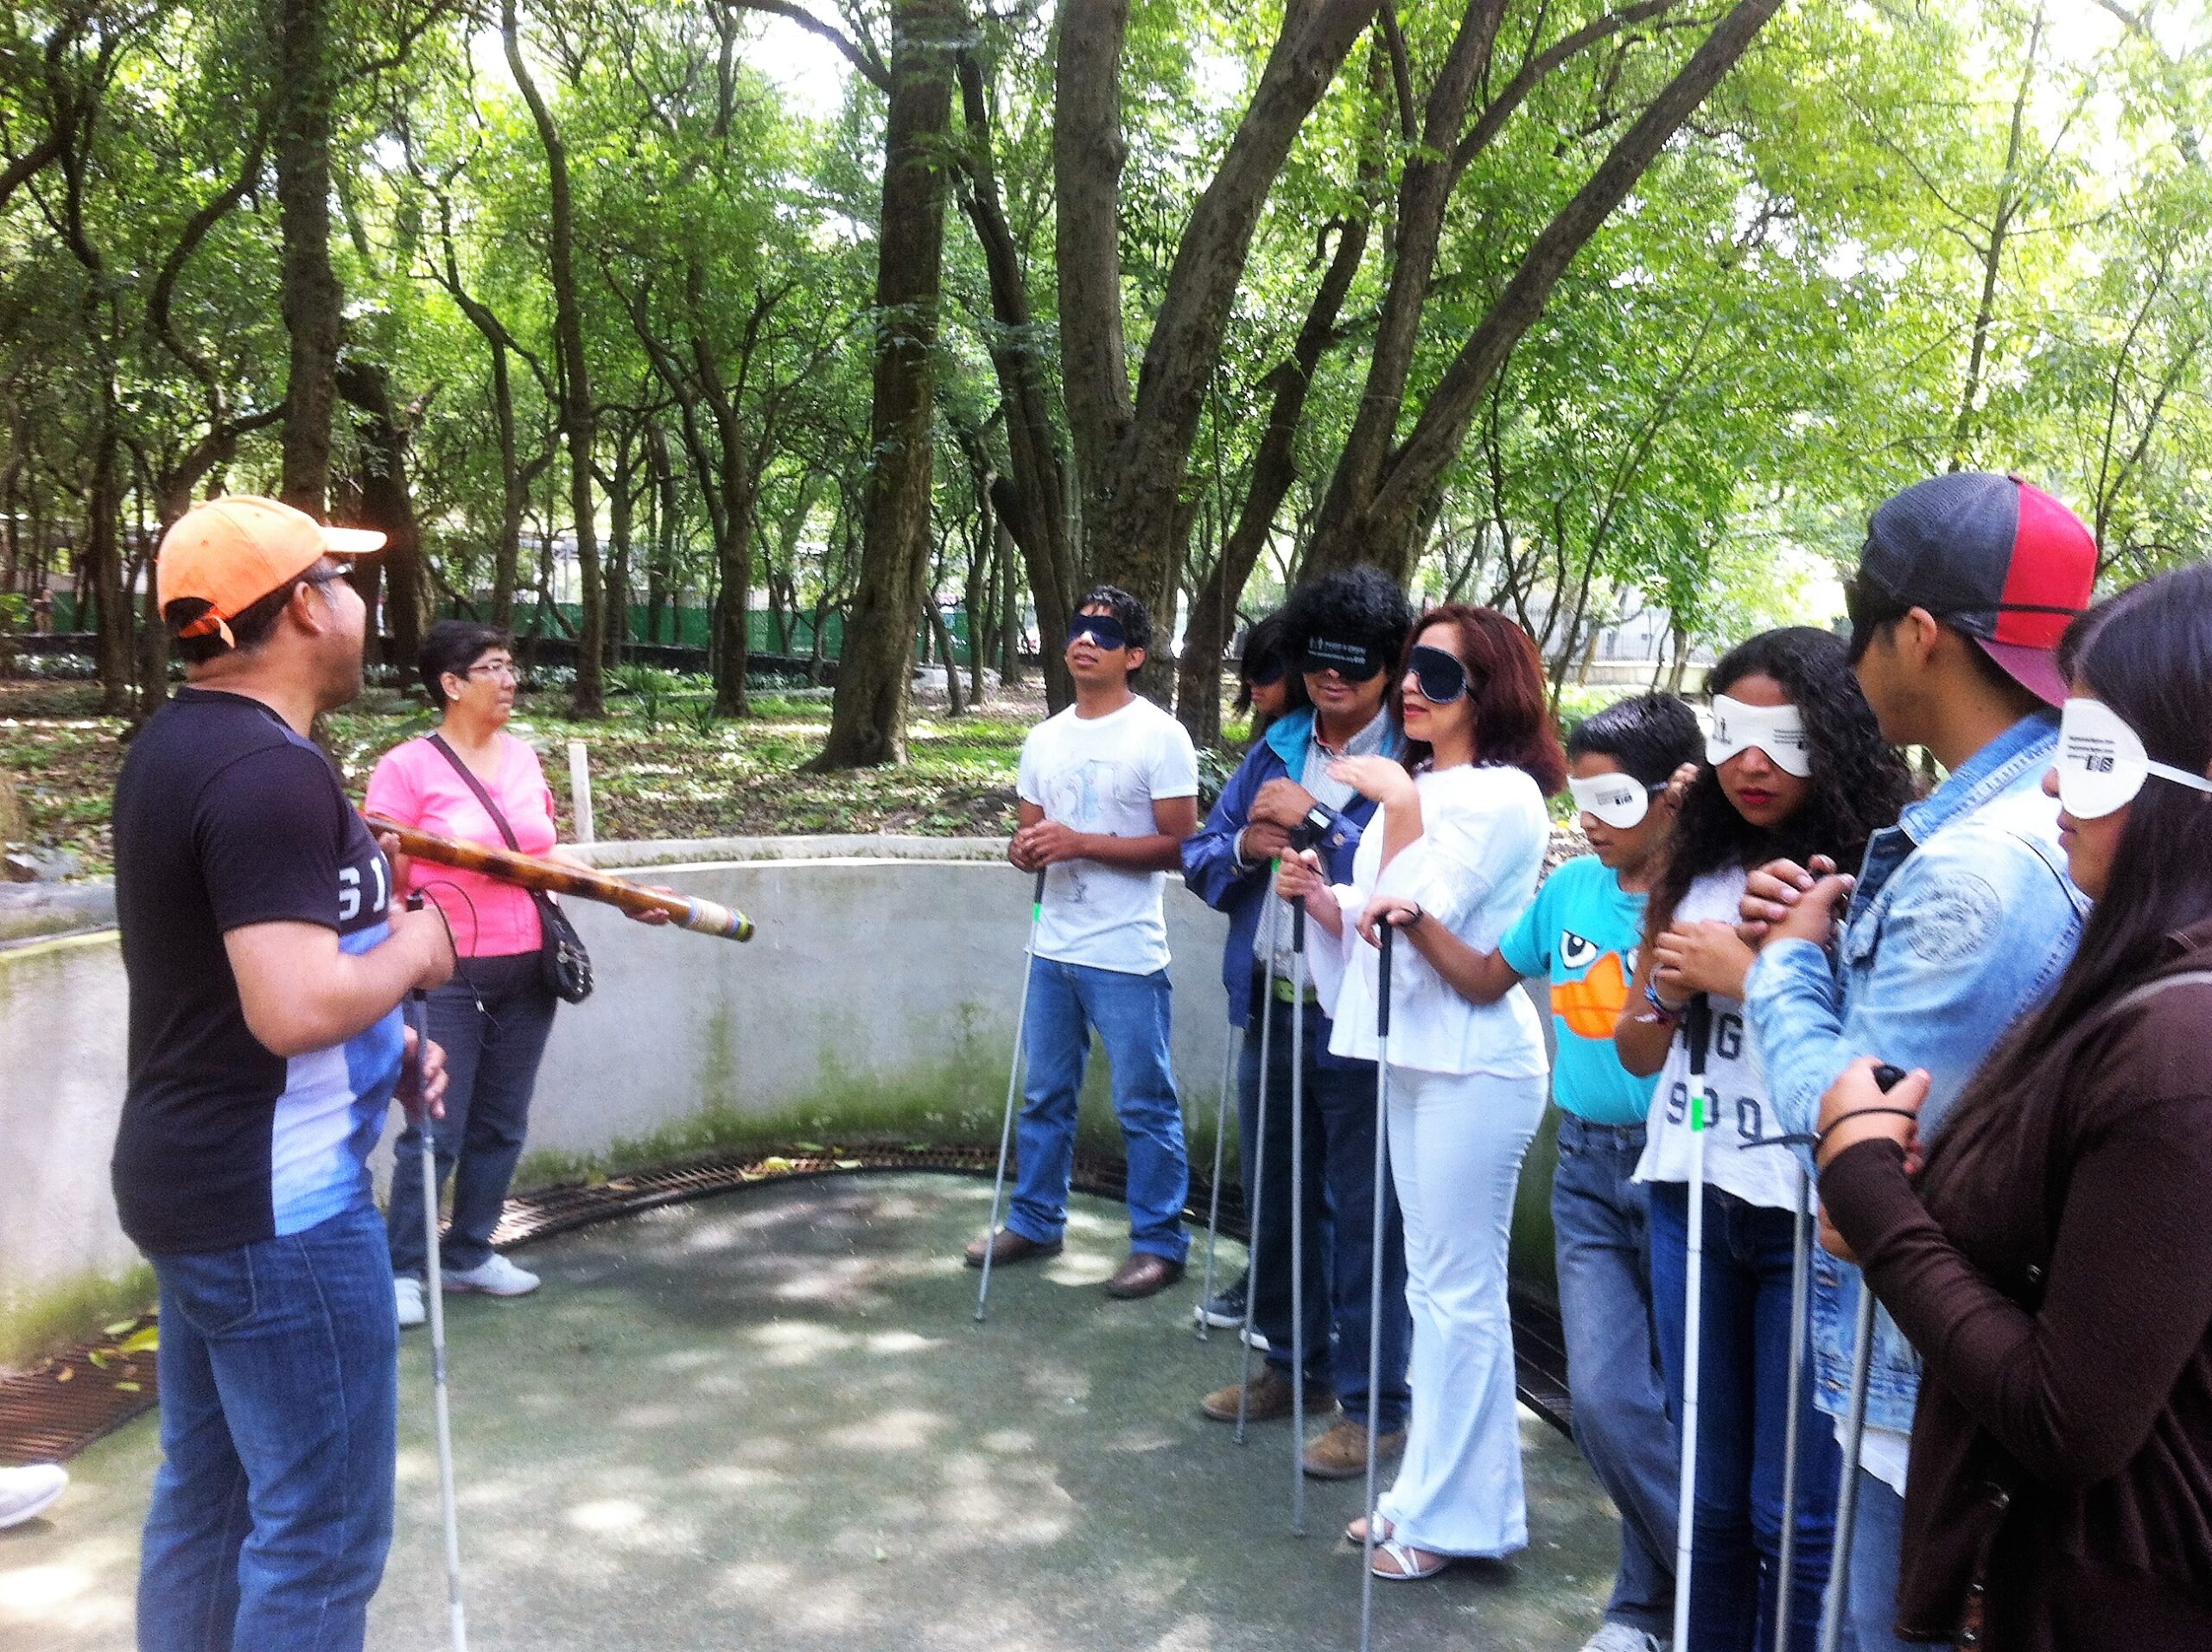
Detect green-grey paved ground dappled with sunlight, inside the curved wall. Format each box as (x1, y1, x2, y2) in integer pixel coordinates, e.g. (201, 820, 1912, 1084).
(0, 1174, 1615, 1652)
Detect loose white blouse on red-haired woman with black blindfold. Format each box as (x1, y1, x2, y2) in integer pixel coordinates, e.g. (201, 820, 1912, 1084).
(1307, 763, 1551, 1079)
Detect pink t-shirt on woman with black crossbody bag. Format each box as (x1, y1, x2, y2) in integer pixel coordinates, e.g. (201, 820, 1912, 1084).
(363, 734, 557, 957)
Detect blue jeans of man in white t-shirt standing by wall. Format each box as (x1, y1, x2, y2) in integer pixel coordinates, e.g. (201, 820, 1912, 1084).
(1007, 957, 1190, 1263)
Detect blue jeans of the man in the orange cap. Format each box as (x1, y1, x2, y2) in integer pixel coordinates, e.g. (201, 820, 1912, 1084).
(137, 1203, 400, 1652)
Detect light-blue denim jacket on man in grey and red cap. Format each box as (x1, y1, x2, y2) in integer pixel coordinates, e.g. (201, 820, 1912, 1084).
(1743, 715, 2088, 1431)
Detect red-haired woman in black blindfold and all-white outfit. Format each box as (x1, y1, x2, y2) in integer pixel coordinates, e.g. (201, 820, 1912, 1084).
(1281, 604, 1566, 1581)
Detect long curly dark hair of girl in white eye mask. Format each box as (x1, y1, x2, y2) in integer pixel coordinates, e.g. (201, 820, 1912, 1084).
(1648, 626, 1916, 936)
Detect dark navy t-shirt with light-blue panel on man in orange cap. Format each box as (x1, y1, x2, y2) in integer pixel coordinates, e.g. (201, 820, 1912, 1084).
(113, 688, 403, 1256)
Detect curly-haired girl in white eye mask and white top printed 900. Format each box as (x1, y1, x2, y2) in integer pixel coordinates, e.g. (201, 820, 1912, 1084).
(1615, 626, 1913, 1652)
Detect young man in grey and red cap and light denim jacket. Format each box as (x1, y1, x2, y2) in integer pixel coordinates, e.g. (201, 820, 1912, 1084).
(1743, 471, 2097, 1652)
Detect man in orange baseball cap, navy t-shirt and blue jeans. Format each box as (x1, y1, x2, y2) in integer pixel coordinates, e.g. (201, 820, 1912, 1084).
(113, 498, 454, 1652)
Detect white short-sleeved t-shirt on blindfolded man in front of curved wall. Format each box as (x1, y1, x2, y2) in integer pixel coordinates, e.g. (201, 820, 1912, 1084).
(1015, 696, 1199, 975)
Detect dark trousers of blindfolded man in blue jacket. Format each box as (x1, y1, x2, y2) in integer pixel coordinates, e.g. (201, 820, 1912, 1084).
(1236, 982, 1414, 1433)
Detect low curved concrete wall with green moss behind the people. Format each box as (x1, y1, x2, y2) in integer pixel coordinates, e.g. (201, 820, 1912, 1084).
(0, 838, 1551, 1363)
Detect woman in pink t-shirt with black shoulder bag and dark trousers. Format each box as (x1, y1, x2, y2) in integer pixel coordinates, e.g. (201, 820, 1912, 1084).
(363, 620, 614, 1325)
